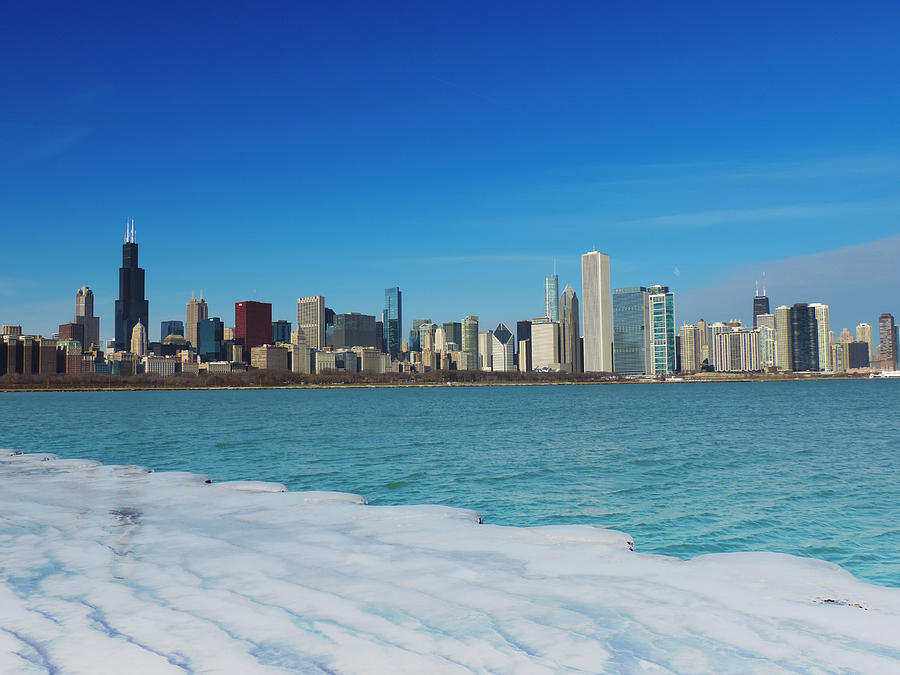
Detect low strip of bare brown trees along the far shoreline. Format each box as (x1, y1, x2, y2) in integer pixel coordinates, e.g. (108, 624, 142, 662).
(0, 370, 867, 392)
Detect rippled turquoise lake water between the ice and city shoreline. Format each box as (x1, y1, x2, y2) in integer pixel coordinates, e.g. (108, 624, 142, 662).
(0, 381, 900, 586)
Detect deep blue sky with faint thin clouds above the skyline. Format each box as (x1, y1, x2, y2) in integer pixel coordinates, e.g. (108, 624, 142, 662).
(0, 2, 900, 339)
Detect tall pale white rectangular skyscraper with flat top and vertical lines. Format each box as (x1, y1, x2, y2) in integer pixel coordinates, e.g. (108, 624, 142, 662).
(584, 251, 613, 373)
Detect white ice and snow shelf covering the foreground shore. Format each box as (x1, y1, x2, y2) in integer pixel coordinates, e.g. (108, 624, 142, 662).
(0, 451, 900, 674)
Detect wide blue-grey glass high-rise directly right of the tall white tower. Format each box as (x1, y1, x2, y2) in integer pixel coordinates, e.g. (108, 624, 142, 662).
(612, 286, 650, 375)
